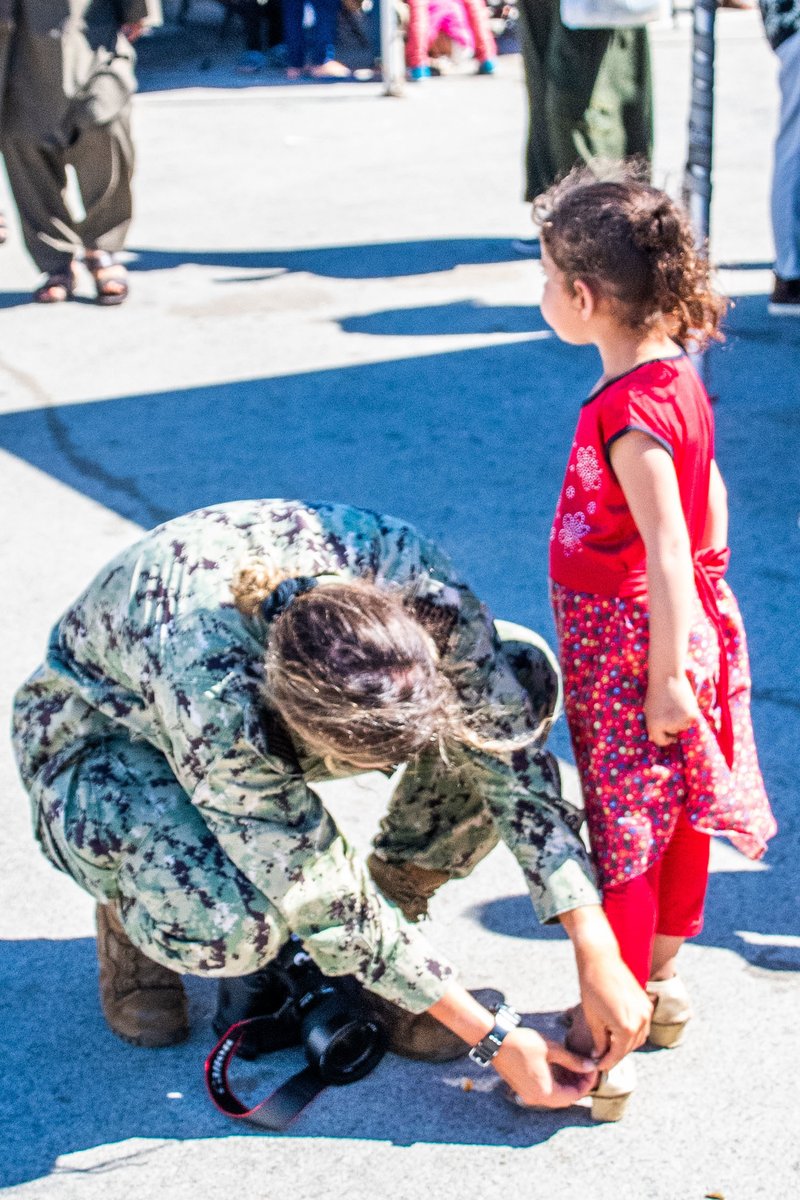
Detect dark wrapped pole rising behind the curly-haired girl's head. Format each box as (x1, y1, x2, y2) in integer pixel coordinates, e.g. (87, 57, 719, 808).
(684, 0, 716, 389)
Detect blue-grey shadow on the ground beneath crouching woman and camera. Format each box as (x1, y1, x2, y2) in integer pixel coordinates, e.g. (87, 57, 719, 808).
(0, 938, 590, 1187)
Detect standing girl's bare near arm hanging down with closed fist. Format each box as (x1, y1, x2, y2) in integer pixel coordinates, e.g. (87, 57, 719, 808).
(610, 431, 699, 746)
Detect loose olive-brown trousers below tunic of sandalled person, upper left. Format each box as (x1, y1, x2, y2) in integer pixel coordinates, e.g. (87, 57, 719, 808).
(2, 112, 133, 275)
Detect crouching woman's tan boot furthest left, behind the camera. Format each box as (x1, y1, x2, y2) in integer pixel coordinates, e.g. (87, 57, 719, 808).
(97, 904, 188, 1048)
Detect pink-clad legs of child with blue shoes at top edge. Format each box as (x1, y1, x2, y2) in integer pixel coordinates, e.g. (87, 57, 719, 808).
(405, 0, 498, 79)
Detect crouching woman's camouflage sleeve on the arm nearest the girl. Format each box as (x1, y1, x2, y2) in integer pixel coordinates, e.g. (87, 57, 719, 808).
(446, 586, 600, 922)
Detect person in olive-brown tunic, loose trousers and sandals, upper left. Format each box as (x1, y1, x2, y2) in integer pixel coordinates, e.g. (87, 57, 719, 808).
(0, 0, 161, 305)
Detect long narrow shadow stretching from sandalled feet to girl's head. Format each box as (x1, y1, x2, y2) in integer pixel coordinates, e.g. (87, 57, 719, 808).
(128, 238, 518, 283)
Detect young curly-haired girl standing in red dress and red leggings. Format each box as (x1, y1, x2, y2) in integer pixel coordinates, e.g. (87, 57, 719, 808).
(535, 172, 775, 1120)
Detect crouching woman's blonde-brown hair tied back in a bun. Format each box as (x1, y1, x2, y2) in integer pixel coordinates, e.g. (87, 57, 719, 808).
(231, 563, 469, 768)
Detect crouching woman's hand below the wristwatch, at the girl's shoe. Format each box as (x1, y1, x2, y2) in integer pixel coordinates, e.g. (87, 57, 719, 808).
(492, 1028, 597, 1109)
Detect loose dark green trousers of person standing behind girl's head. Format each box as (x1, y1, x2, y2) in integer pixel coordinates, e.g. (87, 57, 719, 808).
(517, 0, 652, 200)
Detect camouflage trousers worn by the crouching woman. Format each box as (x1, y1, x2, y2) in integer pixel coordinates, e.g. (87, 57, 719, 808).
(13, 622, 561, 976)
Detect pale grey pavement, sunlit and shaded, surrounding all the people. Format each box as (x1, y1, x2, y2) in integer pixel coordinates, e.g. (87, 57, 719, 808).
(0, 6, 800, 1200)
